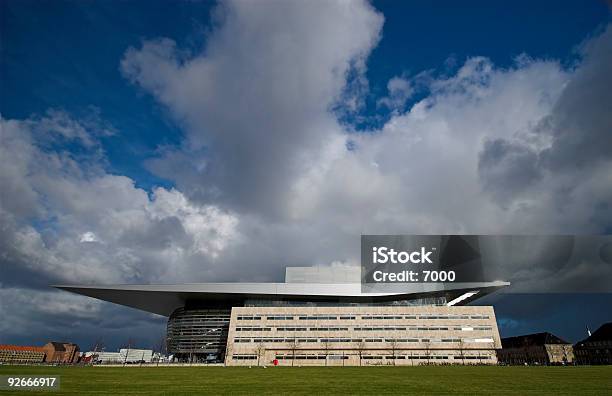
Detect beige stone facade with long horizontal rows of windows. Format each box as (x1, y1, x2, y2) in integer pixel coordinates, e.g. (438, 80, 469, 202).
(226, 306, 501, 366)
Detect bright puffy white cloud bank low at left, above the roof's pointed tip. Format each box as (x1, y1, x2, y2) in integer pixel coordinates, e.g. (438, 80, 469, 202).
(0, 113, 237, 283)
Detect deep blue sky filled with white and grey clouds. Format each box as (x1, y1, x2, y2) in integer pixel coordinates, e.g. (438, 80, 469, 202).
(0, 0, 612, 349)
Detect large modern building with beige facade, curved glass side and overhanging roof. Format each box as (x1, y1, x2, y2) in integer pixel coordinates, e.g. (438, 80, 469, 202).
(56, 267, 509, 365)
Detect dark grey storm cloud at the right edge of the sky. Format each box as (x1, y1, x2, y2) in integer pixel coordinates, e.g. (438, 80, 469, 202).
(478, 26, 612, 209)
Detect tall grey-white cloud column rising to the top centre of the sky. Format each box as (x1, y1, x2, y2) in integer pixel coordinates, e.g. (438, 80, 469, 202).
(121, 1, 383, 215)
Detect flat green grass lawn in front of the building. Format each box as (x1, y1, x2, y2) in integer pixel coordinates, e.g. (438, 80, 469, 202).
(0, 366, 612, 396)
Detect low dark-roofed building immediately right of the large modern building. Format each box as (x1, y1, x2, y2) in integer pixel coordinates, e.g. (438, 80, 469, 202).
(497, 333, 574, 365)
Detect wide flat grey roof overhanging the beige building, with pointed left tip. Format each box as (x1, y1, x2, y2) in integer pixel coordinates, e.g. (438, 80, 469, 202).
(53, 281, 510, 316)
